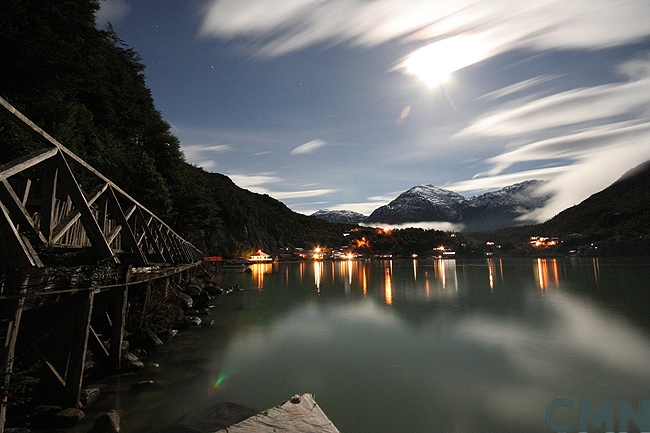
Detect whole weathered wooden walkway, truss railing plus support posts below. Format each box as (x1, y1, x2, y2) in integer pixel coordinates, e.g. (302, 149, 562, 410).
(0, 98, 203, 433)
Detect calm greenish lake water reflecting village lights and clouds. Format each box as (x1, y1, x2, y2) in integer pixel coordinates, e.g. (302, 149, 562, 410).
(73, 258, 650, 433)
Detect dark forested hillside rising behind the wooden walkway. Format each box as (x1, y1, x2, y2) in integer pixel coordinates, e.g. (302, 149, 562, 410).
(0, 0, 352, 256)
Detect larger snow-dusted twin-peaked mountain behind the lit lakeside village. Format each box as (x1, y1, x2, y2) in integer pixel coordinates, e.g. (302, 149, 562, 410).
(365, 180, 550, 230)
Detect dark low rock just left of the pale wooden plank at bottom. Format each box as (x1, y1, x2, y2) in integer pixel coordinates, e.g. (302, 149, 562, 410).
(164, 402, 259, 433)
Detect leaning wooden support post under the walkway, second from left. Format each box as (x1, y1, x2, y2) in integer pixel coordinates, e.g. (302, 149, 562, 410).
(65, 290, 95, 409)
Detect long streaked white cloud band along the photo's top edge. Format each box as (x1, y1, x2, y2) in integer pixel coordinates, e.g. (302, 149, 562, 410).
(200, 0, 650, 61)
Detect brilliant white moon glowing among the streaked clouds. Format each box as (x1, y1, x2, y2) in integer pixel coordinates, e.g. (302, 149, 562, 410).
(402, 35, 485, 87)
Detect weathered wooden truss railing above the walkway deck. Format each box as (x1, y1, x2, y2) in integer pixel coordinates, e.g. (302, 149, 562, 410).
(0, 98, 203, 268)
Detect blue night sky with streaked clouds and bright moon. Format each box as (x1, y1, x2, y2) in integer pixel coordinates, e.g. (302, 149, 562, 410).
(97, 0, 650, 226)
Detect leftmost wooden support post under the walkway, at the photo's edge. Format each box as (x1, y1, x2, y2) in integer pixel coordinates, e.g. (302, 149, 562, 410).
(0, 274, 26, 433)
